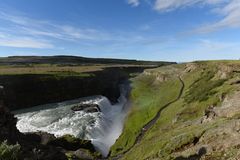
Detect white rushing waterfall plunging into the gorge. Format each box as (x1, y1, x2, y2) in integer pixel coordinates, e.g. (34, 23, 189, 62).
(14, 84, 129, 156)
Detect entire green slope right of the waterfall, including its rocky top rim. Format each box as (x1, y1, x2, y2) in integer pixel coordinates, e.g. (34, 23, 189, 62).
(111, 61, 240, 160)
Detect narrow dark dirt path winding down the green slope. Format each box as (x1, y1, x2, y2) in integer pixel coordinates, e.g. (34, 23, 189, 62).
(109, 77, 185, 160)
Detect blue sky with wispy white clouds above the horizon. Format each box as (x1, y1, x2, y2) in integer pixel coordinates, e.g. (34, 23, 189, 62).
(0, 0, 240, 62)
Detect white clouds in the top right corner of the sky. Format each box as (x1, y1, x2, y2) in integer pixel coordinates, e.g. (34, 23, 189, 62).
(150, 0, 240, 33)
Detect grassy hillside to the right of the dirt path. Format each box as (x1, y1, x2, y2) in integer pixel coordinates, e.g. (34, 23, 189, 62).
(111, 62, 239, 160)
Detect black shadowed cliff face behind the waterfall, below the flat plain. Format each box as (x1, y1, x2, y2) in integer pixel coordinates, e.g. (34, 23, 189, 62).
(0, 68, 131, 110)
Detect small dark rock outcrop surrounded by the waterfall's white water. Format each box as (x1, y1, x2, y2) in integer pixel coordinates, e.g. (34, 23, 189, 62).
(71, 103, 101, 113)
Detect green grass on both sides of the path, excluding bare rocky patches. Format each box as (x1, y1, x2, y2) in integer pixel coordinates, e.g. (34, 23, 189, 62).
(112, 61, 240, 160)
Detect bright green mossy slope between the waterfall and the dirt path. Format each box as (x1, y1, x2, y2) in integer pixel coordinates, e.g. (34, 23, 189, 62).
(111, 64, 184, 156)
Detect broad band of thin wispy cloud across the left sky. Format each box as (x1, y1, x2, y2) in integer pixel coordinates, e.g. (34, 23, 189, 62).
(0, 8, 169, 50)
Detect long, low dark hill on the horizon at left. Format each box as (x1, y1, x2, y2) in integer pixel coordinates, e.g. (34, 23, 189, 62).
(0, 56, 173, 66)
